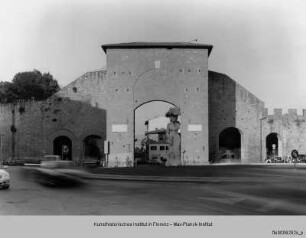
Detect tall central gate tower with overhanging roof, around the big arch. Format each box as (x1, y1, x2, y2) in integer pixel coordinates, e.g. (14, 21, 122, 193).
(102, 43, 212, 167)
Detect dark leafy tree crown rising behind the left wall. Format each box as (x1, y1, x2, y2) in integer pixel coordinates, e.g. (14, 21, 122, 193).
(0, 70, 60, 103)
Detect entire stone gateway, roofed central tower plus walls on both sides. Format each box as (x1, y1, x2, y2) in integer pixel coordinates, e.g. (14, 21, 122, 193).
(0, 43, 306, 167)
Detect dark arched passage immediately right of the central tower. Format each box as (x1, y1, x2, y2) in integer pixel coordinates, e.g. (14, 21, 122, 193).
(219, 127, 241, 160)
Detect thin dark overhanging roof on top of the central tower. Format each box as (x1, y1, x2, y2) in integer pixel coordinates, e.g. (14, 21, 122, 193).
(102, 42, 213, 55)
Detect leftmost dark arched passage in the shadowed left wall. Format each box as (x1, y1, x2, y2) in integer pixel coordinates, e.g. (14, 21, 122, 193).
(53, 136, 72, 160)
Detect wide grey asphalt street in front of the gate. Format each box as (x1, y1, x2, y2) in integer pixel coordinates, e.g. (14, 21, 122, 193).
(0, 166, 306, 215)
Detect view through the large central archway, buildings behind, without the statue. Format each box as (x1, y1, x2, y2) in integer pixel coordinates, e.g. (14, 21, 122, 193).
(134, 100, 181, 166)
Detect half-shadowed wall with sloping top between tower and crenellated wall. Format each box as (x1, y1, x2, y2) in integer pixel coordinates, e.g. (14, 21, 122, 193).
(209, 71, 264, 163)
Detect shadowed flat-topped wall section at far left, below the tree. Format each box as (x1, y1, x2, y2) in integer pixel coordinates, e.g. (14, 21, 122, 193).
(0, 101, 44, 160)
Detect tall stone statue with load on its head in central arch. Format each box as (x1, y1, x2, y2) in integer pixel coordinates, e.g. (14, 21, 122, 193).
(166, 108, 181, 166)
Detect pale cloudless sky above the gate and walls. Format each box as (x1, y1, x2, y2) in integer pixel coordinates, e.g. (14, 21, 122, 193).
(0, 0, 306, 113)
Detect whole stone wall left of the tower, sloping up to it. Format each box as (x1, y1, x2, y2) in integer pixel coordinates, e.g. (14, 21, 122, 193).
(0, 71, 106, 161)
